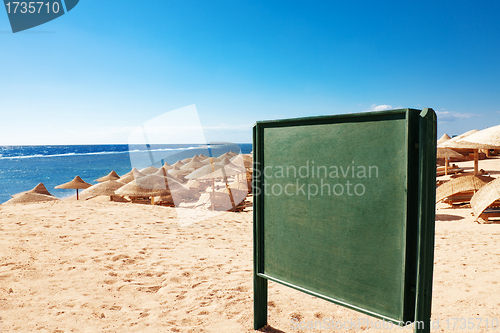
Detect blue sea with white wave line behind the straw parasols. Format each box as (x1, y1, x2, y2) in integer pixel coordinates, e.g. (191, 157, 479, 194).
(0, 143, 252, 203)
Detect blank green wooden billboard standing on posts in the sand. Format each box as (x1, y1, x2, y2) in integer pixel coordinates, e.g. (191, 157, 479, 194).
(254, 109, 436, 326)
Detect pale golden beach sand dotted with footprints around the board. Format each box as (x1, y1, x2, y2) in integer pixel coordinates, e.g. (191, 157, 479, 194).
(0, 160, 500, 333)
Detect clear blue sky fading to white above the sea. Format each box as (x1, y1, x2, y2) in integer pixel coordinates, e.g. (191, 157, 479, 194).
(0, 0, 500, 145)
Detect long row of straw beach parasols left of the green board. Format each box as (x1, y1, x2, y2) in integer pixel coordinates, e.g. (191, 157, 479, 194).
(2, 152, 252, 208)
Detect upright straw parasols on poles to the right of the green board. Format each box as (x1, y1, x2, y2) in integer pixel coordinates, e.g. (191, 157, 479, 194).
(437, 125, 500, 175)
